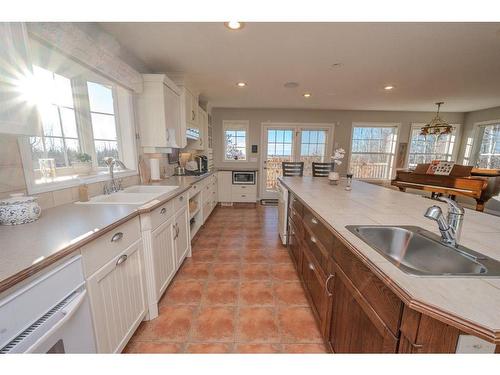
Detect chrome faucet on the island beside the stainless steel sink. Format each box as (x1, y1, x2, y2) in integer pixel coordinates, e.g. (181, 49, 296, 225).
(424, 197, 465, 247)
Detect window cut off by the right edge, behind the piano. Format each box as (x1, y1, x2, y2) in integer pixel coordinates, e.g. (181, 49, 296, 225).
(476, 122, 500, 169)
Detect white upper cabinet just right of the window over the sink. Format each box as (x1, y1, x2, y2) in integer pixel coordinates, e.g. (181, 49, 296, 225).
(138, 74, 186, 152)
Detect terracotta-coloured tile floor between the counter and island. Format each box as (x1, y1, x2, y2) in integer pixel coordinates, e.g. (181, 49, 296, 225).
(125, 206, 325, 353)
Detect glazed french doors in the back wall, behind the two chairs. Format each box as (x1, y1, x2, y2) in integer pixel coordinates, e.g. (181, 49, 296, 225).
(259, 124, 333, 199)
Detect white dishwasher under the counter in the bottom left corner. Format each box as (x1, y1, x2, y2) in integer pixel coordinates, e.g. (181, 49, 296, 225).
(0, 255, 96, 354)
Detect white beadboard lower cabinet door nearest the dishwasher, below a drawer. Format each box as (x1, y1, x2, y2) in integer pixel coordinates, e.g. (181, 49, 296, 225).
(87, 240, 146, 353)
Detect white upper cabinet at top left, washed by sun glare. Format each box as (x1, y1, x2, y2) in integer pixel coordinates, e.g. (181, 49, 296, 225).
(0, 22, 41, 135)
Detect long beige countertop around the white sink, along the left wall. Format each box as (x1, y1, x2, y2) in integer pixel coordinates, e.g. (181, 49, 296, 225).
(0, 172, 213, 292)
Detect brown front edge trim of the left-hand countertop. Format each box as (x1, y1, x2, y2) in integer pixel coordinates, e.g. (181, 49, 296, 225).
(0, 171, 214, 294)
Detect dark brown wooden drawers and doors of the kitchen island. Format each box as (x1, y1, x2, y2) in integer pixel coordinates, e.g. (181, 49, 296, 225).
(288, 192, 498, 353)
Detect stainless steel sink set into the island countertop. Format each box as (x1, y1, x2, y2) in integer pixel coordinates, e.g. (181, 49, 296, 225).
(346, 225, 500, 277)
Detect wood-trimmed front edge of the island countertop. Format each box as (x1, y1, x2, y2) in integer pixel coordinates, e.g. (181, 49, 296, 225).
(279, 177, 500, 344)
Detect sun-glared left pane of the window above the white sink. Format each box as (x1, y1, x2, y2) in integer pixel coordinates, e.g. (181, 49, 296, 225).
(29, 66, 80, 169)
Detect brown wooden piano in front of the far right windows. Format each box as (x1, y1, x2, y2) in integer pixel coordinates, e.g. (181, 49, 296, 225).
(391, 164, 500, 212)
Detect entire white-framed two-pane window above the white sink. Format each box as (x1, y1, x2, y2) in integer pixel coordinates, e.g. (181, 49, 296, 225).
(19, 39, 137, 194)
